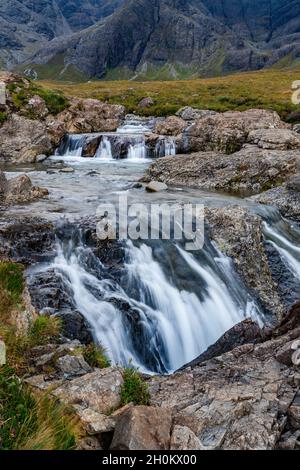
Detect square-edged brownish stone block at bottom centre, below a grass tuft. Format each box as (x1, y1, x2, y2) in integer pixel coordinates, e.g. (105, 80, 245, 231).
(110, 406, 172, 450)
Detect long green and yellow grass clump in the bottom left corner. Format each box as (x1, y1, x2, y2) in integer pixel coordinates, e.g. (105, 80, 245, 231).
(0, 367, 77, 450)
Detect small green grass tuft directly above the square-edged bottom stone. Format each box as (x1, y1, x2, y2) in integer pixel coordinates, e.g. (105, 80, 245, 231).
(121, 368, 150, 406)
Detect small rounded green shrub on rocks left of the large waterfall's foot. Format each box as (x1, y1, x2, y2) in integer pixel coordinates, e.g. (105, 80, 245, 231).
(28, 316, 62, 347)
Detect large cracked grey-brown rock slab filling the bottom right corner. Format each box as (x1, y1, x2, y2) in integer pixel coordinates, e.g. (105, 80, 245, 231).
(149, 318, 300, 450)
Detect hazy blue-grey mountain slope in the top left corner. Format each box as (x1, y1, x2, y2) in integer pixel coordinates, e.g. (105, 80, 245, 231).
(0, 0, 124, 68)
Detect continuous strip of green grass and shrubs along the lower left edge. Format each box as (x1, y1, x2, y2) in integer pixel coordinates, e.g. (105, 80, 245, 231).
(0, 261, 78, 450)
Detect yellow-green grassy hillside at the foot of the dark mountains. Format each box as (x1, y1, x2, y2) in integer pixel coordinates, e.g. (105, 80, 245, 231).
(39, 68, 300, 120)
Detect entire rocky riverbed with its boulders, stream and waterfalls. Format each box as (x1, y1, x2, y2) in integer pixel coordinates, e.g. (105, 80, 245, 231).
(0, 74, 300, 450)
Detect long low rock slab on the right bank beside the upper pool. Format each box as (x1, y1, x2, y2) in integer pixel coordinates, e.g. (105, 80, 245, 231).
(145, 146, 300, 195)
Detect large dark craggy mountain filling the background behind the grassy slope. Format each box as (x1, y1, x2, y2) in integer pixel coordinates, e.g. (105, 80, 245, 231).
(0, 0, 300, 79)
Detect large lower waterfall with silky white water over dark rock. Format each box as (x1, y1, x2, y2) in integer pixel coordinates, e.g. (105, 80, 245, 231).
(34, 231, 263, 373)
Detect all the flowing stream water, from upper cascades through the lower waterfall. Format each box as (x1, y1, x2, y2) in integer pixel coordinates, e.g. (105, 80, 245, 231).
(2, 123, 300, 373)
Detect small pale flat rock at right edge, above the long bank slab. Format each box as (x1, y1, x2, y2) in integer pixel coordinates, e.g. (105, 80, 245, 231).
(247, 129, 300, 150)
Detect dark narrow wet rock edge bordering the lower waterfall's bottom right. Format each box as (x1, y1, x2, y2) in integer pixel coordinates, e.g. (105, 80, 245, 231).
(180, 319, 263, 370)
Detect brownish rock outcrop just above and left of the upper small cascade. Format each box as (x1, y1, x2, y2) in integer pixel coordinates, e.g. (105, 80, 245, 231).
(57, 99, 125, 133)
